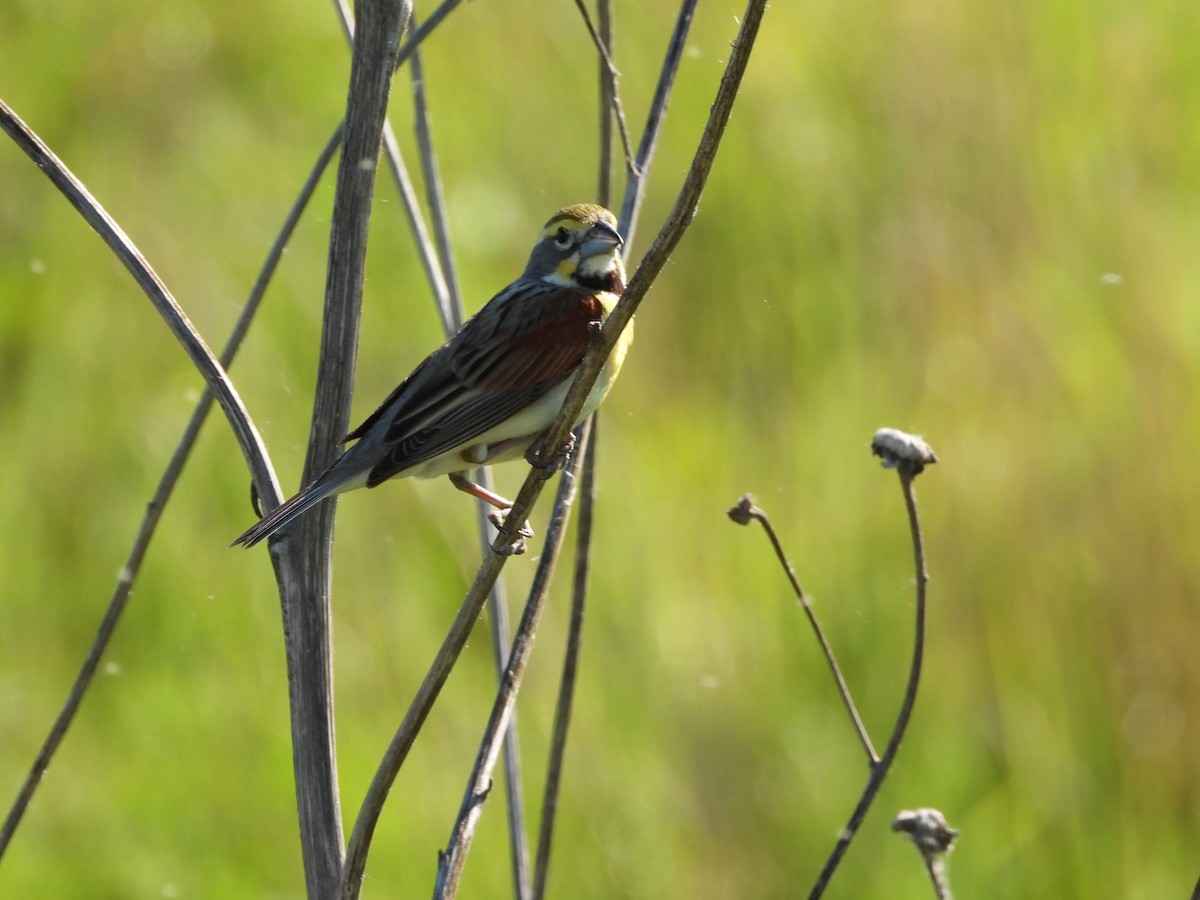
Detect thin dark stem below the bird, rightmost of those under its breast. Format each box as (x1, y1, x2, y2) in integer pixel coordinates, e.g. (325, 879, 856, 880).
(533, 415, 600, 900)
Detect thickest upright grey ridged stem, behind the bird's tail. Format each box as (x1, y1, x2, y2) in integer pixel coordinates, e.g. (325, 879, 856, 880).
(270, 0, 412, 898)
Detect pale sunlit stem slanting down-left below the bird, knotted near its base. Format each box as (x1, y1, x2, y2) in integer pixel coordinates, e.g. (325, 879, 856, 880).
(433, 422, 590, 900)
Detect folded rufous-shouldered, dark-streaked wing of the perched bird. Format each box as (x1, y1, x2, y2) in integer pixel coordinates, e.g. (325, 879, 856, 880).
(352, 281, 604, 485)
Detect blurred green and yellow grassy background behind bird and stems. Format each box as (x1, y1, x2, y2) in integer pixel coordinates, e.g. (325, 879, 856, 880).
(0, 0, 1200, 898)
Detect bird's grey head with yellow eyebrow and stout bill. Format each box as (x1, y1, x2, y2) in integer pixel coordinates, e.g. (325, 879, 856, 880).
(526, 203, 625, 294)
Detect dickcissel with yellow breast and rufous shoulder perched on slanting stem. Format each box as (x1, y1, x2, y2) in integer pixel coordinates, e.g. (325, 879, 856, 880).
(234, 203, 634, 547)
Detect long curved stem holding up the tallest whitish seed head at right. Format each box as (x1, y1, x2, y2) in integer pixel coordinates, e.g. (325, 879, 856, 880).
(809, 458, 929, 900)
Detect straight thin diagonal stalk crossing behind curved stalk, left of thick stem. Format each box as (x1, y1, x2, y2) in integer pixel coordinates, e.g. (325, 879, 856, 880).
(0, 123, 340, 858)
